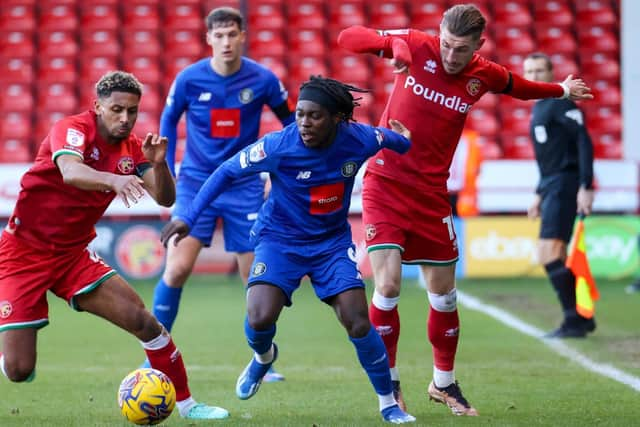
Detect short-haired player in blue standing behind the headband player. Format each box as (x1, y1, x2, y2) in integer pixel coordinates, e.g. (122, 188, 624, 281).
(147, 7, 294, 381)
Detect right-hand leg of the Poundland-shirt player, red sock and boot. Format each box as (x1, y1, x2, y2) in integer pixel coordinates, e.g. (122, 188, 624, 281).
(421, 264, 478, 416)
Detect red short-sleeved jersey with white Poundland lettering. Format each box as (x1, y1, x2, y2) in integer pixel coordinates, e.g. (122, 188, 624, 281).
(367, 30, 508, 190)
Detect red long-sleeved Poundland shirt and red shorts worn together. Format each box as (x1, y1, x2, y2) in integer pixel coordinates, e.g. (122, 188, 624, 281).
(339, 27, 563, 264)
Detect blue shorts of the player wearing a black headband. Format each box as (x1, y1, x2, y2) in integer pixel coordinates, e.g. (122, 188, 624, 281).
(248, 238, 365, 306)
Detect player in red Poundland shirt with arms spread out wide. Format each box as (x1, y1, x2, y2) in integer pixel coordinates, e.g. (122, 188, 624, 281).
(338, 5, 592, 415)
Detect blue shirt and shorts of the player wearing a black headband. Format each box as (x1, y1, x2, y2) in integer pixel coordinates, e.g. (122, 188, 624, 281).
(176, 122, 410, 305)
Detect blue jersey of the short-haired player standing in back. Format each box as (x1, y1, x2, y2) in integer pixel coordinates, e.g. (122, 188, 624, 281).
(161, 57, 289, 179)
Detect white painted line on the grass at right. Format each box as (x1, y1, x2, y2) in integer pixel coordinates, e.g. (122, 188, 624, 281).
(458, 289, 640, 391)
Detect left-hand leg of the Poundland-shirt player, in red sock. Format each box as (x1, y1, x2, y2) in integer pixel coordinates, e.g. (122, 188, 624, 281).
(369, 249, 407, 411)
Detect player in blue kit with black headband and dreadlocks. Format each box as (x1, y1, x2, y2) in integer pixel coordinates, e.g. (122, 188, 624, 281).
(162, 77, 415, 424)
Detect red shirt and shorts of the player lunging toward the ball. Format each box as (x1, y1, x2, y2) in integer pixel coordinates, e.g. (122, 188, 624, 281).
(0, 111, 150, 332)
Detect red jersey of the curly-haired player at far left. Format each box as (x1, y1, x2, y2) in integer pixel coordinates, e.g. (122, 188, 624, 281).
(7, 111, 150, 250)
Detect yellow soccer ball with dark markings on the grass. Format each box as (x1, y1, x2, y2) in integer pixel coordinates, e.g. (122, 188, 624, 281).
(118, 368, 176, 425)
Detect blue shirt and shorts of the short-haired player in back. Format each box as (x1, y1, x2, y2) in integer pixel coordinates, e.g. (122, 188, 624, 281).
(160, 57, 294, 252)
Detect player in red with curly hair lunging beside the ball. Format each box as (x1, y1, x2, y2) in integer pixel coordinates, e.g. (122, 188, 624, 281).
(0, 71, 229, 419)
